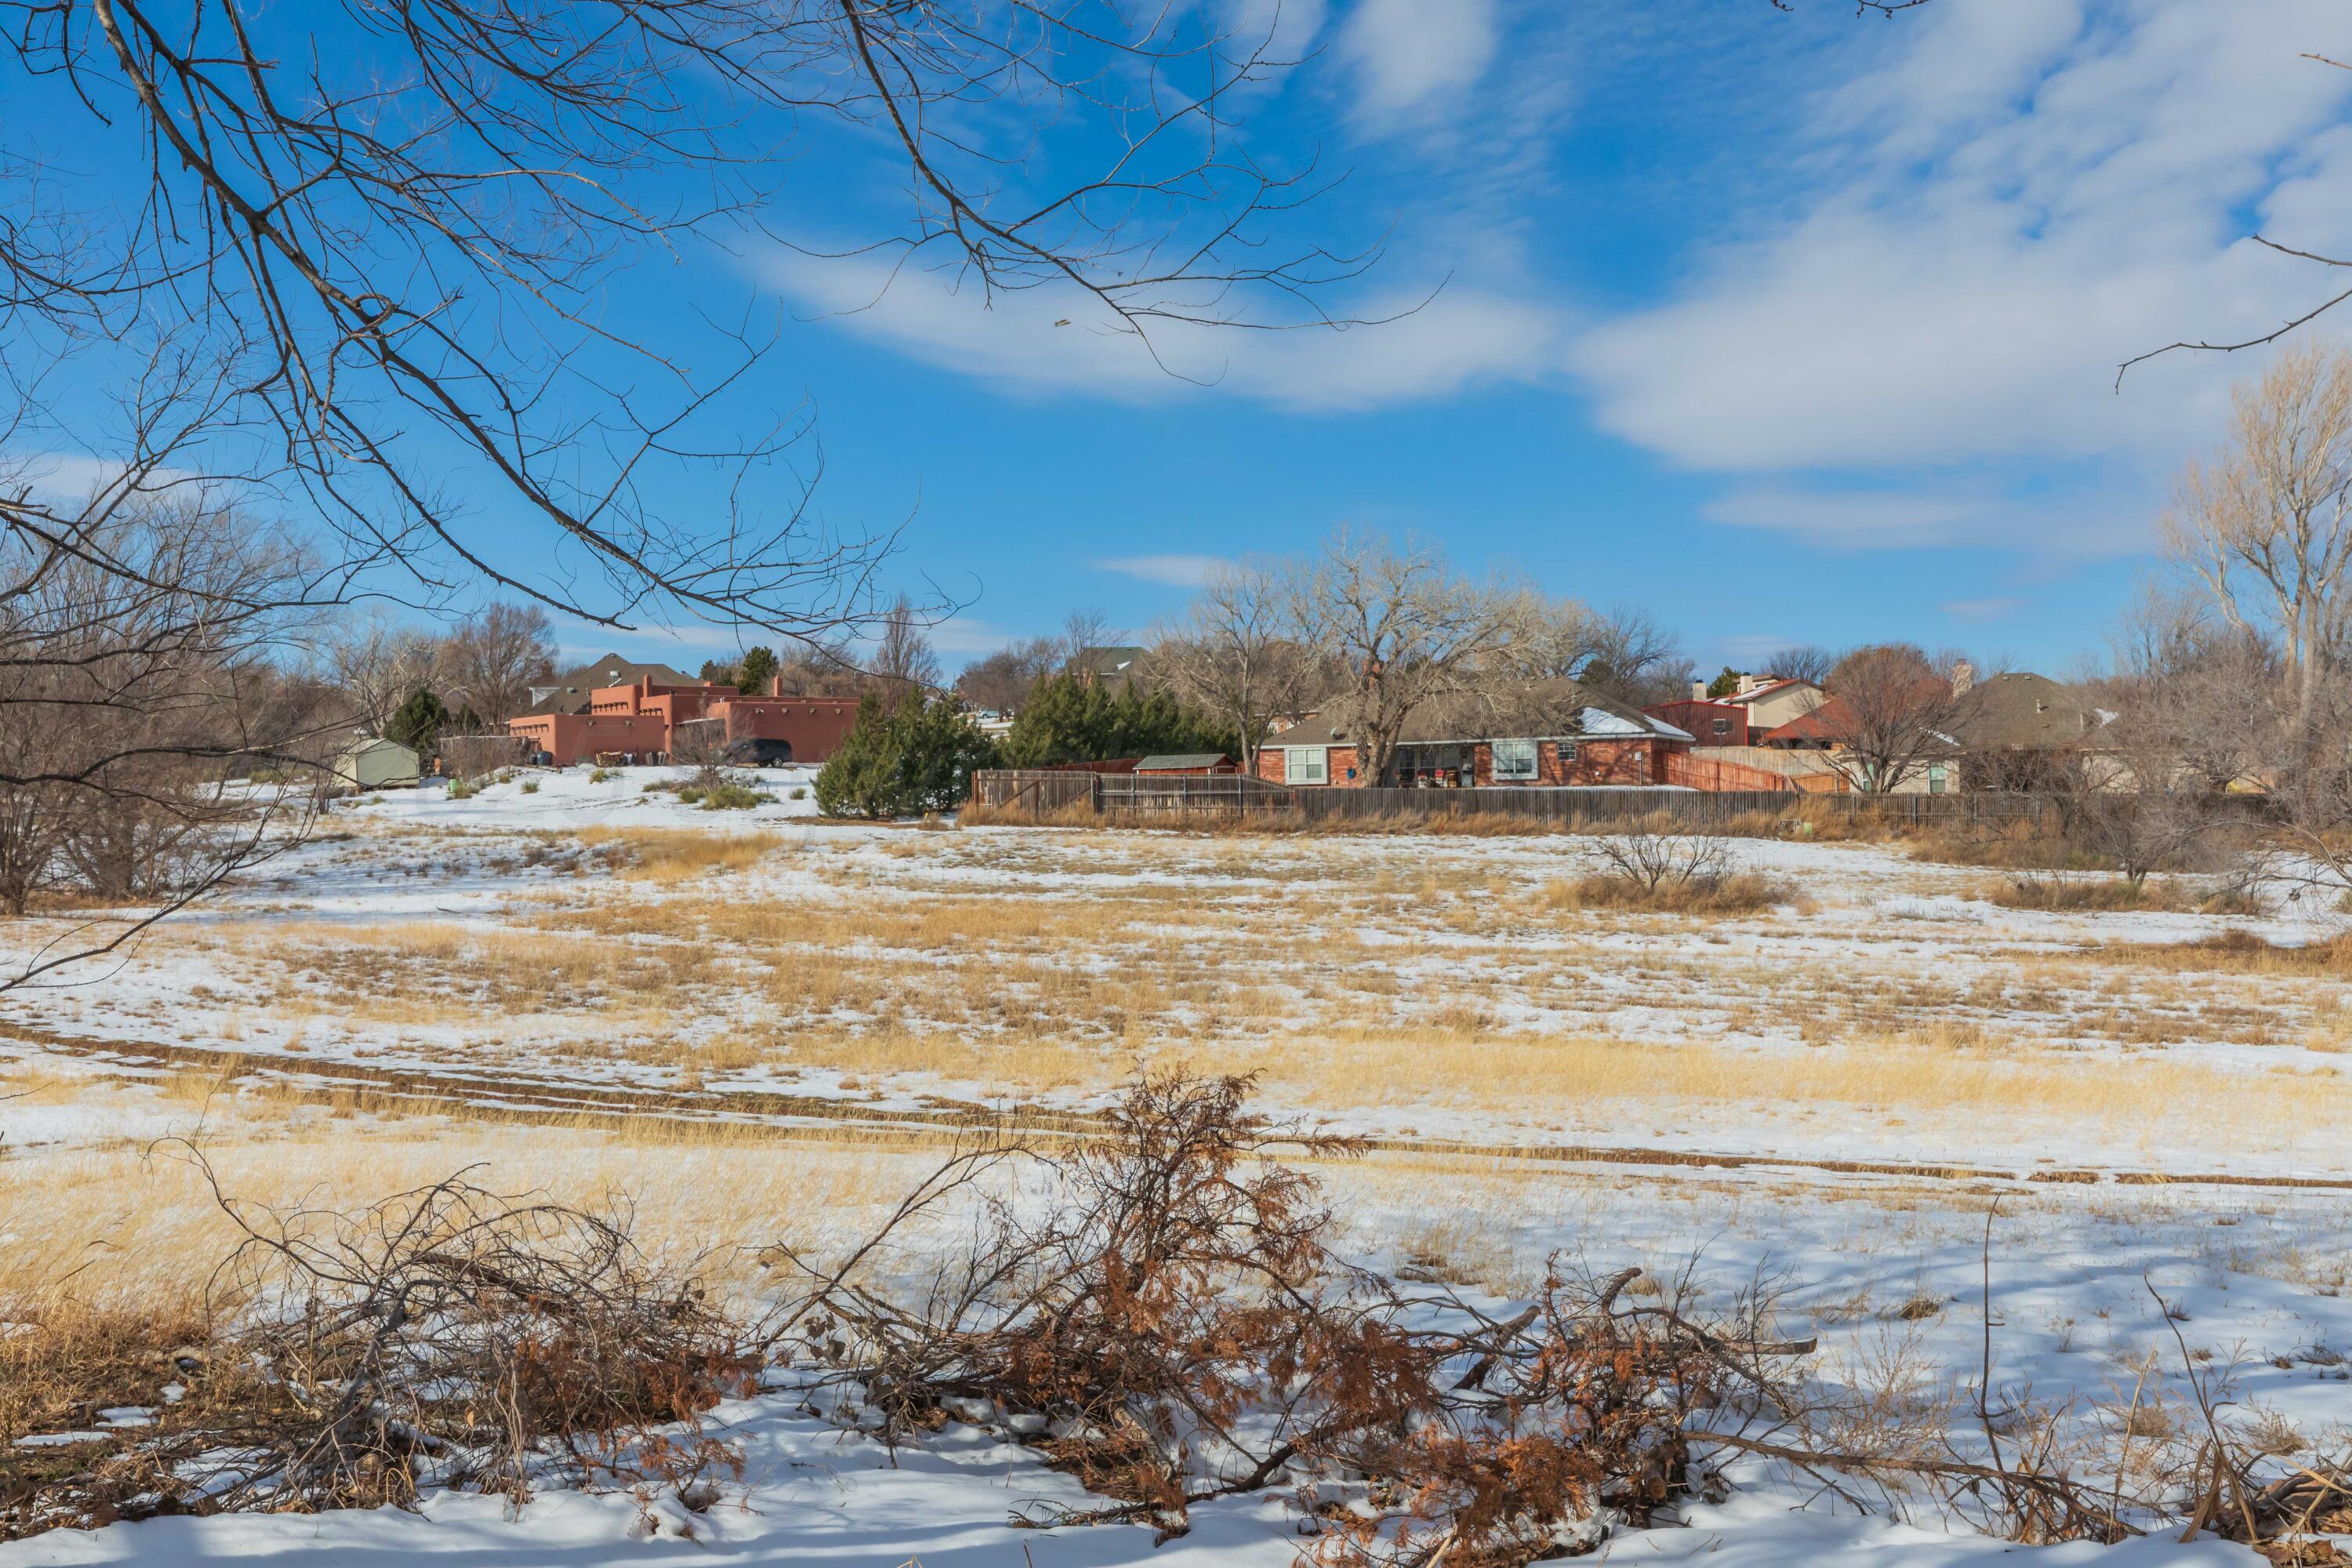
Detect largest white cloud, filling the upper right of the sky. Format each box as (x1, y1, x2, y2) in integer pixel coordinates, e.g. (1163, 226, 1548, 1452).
(1569, 0, 2352, 543)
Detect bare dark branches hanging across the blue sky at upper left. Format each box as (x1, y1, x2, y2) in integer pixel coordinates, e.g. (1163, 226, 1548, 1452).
(0, 0, 1369, 637)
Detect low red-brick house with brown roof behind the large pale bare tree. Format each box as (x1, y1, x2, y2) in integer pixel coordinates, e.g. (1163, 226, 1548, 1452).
(1258, 680, 1691, 789)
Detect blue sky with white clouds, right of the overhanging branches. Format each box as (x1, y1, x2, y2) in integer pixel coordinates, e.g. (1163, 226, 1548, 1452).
(18, 0, 2352, 670)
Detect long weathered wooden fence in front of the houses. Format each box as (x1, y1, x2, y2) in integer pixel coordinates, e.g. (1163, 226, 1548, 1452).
(971, 769, 2201, 827)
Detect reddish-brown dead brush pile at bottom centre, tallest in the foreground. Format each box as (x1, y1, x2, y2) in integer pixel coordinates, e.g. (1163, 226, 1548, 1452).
(776, 1072, 1811, 1568)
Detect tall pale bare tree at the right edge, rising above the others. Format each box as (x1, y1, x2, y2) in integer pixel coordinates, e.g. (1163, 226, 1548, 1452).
(2164, 343, 2352, 717)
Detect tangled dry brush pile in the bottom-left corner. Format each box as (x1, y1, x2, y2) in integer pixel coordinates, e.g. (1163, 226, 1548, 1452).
(0, 1159, 757, 1540)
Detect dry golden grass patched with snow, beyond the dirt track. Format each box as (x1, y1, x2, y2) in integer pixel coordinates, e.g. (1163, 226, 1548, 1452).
(32, 799, 2352, 1166)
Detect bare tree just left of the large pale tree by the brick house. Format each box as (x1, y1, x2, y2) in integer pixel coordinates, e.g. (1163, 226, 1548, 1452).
(1150, 560, 1329, 774)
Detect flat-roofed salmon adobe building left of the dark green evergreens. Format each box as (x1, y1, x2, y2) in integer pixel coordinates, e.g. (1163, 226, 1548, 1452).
(506, 677, 858, 767)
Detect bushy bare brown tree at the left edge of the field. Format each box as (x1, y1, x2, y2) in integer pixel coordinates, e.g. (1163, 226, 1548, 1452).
(0, 496, 325, 989)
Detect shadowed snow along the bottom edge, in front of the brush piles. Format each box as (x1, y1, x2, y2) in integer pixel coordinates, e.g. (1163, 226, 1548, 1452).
(0, 1396, 2263, 1568)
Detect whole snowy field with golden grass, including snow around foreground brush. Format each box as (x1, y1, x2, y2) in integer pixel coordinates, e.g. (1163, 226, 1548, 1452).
(0, 769, 2352, 1568)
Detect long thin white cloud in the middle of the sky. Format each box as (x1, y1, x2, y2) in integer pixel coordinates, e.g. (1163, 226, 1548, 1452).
(764, 252, 1562, 409)
